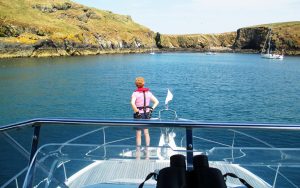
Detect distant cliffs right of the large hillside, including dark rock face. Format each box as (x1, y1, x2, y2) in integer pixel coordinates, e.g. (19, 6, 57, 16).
(156, 22, 300, 55)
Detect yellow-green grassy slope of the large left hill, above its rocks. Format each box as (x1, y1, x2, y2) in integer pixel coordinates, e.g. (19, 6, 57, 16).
(0, 0, 154, 44)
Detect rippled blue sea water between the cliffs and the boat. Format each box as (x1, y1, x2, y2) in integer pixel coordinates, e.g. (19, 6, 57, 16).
(0, 53, 300, 187)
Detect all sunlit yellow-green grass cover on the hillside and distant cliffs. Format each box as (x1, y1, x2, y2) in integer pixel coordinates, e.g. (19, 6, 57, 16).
(0, 0, 300, 51)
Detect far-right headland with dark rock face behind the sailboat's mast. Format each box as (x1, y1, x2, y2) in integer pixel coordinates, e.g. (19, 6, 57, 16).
(233, 22, 300, 55)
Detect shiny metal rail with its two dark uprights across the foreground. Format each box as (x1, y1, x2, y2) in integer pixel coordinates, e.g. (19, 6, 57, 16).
(0, 118, 300, 187)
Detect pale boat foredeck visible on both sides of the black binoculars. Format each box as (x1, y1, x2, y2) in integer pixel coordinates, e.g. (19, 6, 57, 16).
(66, 159, 271, 188)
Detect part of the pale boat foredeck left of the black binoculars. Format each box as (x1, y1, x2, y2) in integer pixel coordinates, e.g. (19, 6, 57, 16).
(67, 159, 170, 188)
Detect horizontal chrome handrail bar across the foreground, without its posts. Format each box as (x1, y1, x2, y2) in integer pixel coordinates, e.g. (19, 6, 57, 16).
(0, 118, 300, 132)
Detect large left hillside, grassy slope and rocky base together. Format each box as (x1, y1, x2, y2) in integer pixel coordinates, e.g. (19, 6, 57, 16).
(0, 0, 156, 57)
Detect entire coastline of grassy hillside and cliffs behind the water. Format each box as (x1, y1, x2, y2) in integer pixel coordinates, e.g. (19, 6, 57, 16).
(0, 0, 300, 58)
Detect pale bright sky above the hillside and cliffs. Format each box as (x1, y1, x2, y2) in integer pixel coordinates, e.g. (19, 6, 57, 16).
(73, 0, 300, 34)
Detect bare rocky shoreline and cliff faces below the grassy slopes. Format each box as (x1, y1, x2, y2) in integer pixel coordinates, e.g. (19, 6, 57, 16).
(0, 24, 300, 58)
